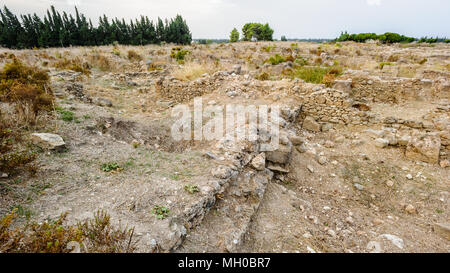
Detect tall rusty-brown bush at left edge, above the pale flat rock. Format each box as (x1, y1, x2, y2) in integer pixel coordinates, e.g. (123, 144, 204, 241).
(0, 58, 54, 174)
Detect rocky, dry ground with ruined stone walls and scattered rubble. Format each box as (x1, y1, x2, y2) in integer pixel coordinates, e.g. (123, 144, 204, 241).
(0, 42, 450, 253)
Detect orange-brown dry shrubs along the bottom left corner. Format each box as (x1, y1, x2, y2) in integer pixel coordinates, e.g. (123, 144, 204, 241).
(0, 211, 136, 253)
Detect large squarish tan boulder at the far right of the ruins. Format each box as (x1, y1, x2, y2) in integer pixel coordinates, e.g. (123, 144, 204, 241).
(405, 134, 441, 164)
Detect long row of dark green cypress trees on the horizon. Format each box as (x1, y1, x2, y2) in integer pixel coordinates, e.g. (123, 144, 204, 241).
(0, 6, 192, 49)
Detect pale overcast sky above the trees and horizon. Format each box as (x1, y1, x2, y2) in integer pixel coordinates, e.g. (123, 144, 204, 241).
(0, 0, 450, 39)
